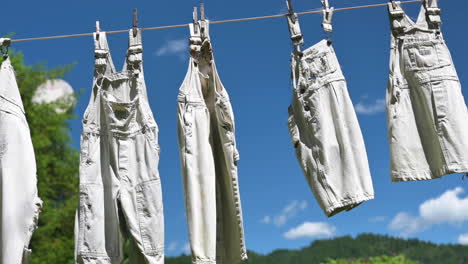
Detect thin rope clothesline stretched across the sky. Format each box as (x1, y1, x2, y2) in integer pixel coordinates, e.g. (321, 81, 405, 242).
(7, 0, 421, 42)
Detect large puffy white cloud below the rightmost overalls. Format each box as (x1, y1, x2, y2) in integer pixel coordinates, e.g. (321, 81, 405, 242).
(389, 187, 468, 236)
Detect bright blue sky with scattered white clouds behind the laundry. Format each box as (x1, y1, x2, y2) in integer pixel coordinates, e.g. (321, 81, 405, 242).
(0, 0, 468, 255)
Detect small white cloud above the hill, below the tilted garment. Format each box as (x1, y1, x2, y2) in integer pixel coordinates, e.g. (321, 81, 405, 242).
(283, 222, 336, 239)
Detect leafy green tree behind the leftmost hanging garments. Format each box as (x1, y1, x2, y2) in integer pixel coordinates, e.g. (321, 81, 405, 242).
(0, 52, 79, 264)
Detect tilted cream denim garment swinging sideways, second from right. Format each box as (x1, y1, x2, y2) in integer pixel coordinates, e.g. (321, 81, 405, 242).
(288, 40, 374, 217)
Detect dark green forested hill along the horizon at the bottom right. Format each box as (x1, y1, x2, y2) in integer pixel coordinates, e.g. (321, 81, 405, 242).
(166, 234, 468, 264)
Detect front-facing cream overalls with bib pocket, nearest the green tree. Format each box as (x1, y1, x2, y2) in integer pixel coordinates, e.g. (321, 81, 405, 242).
(75, 30, 164, 264)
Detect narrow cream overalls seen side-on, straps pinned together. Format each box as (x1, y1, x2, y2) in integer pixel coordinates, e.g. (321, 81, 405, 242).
(178, 23, 247, 264)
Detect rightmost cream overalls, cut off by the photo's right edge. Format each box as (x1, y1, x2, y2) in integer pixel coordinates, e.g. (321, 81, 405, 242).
(387, 1, 468, 181)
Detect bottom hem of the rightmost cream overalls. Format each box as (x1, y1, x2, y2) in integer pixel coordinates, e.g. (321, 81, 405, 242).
(391, 163, 468, 182)
